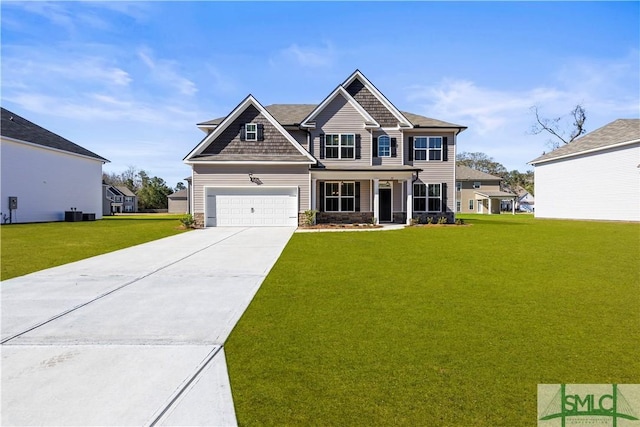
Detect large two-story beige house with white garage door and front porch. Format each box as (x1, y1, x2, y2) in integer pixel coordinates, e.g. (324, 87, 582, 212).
(184, 70, 466, 227)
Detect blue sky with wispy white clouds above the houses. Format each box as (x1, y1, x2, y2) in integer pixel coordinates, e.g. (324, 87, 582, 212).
(0, 1, 640, 186)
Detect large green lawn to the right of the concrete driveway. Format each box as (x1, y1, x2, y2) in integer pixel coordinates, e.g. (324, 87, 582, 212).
(225, 215, 640, 426)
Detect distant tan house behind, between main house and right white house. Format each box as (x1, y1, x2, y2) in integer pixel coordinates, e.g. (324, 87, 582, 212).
(456, 165, 517, 214)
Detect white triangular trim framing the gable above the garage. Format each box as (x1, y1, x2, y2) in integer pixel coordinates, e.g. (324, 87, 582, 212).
(183, 95, 316, 164)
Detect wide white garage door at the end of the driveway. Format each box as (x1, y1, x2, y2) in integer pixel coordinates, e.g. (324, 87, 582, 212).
(205, 187, 298, 227)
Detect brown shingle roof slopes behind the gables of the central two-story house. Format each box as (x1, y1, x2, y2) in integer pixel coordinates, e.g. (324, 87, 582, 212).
(198, 104, 466, 129)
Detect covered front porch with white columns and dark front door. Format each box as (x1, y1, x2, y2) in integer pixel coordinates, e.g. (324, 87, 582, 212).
(309, 166, 420, 224)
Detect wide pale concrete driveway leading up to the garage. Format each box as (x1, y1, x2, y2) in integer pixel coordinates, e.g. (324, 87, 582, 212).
(1, 227, 295, 426)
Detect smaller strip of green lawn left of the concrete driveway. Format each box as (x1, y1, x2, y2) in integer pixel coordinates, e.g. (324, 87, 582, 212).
(0, 214, 184, 280)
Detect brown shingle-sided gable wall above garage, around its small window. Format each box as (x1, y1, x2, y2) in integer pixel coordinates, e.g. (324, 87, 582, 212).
(202, 105, 300, 159)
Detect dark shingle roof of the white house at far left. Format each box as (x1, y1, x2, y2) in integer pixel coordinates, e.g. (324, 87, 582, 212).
(0, 108, 109, 162)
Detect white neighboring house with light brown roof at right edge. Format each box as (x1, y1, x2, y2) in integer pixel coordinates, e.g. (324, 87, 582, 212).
(529, 119, 640, 221)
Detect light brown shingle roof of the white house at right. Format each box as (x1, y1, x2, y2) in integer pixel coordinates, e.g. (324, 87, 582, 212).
(529, 119, 640, 165)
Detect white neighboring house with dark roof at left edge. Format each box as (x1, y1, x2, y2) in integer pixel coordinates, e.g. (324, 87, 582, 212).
(0, 108, 108, 223)
